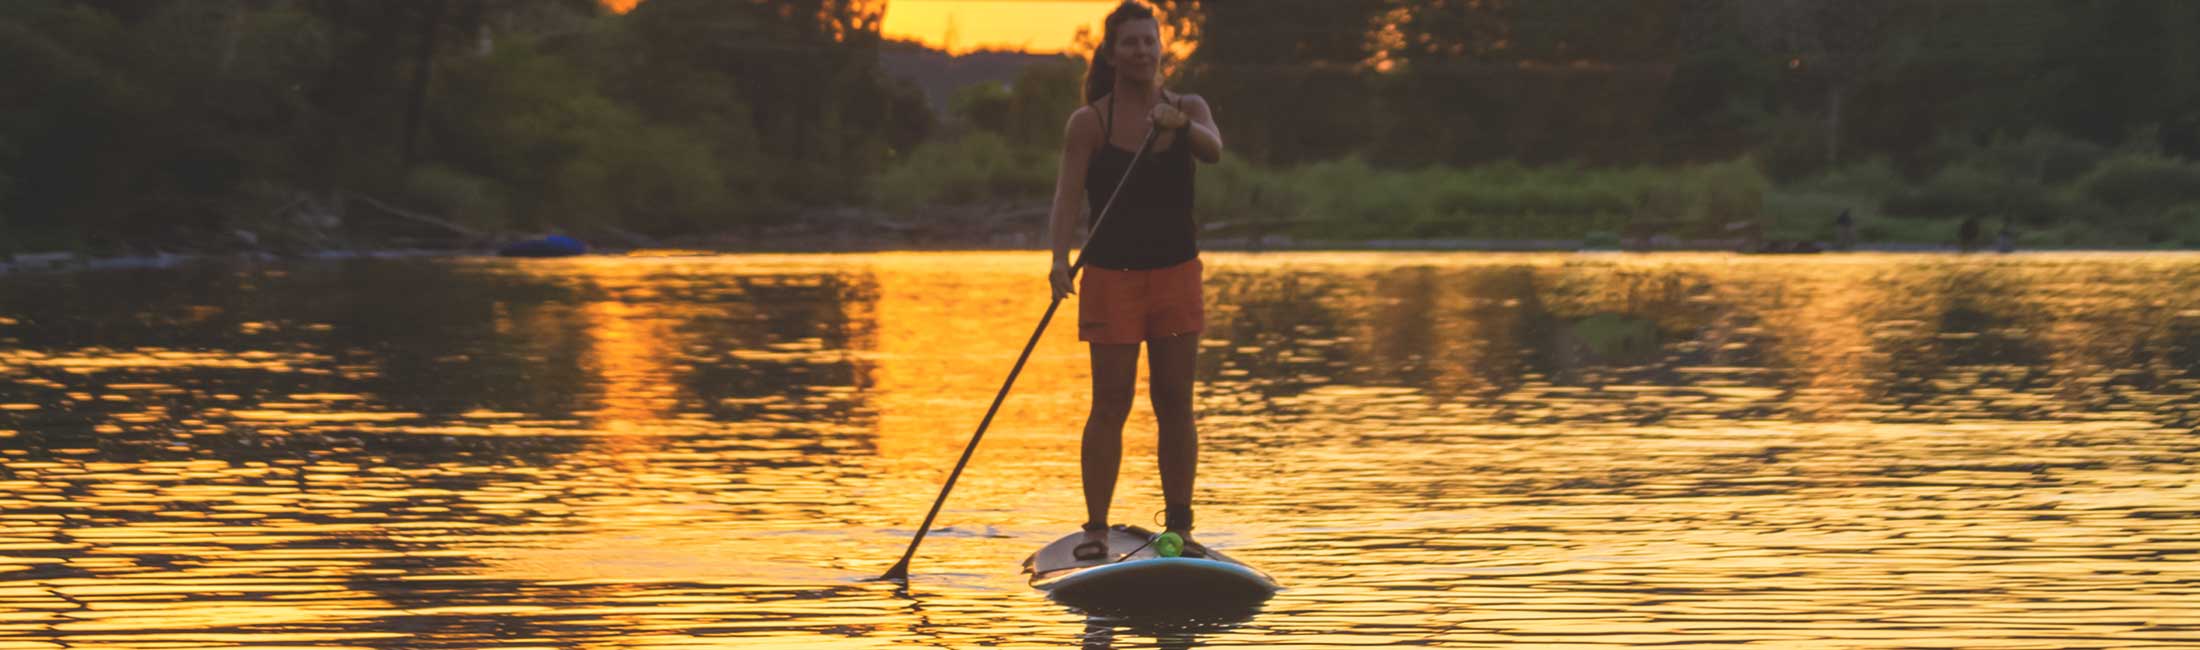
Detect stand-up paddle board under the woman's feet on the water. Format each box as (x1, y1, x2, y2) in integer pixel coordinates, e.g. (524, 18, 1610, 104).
(1023, 524, 1280, 610)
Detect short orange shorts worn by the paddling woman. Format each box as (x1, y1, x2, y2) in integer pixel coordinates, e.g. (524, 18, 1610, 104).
(1078, 258, 1208, 344)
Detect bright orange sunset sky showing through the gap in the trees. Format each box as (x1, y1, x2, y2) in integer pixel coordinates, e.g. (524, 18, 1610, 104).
(603, 0, 1118, 53)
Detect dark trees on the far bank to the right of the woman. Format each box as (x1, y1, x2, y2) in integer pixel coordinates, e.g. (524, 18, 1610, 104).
(1159, 0, 2200, 174)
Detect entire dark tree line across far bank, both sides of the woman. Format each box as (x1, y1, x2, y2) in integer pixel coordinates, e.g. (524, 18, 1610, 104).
(0, 0, 2200, 249)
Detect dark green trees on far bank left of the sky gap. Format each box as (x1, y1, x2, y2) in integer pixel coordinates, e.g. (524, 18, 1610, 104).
(0, 0, 910, 242)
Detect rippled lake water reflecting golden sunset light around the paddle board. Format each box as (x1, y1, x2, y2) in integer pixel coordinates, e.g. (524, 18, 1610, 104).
(0, 253, 2200, 648)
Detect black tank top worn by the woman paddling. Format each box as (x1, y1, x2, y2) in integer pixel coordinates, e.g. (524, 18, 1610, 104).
(1085, 93, 1199, 269)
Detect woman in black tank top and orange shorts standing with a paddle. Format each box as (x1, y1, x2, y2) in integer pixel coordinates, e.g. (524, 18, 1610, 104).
(1047, 0, 1223, 560)
